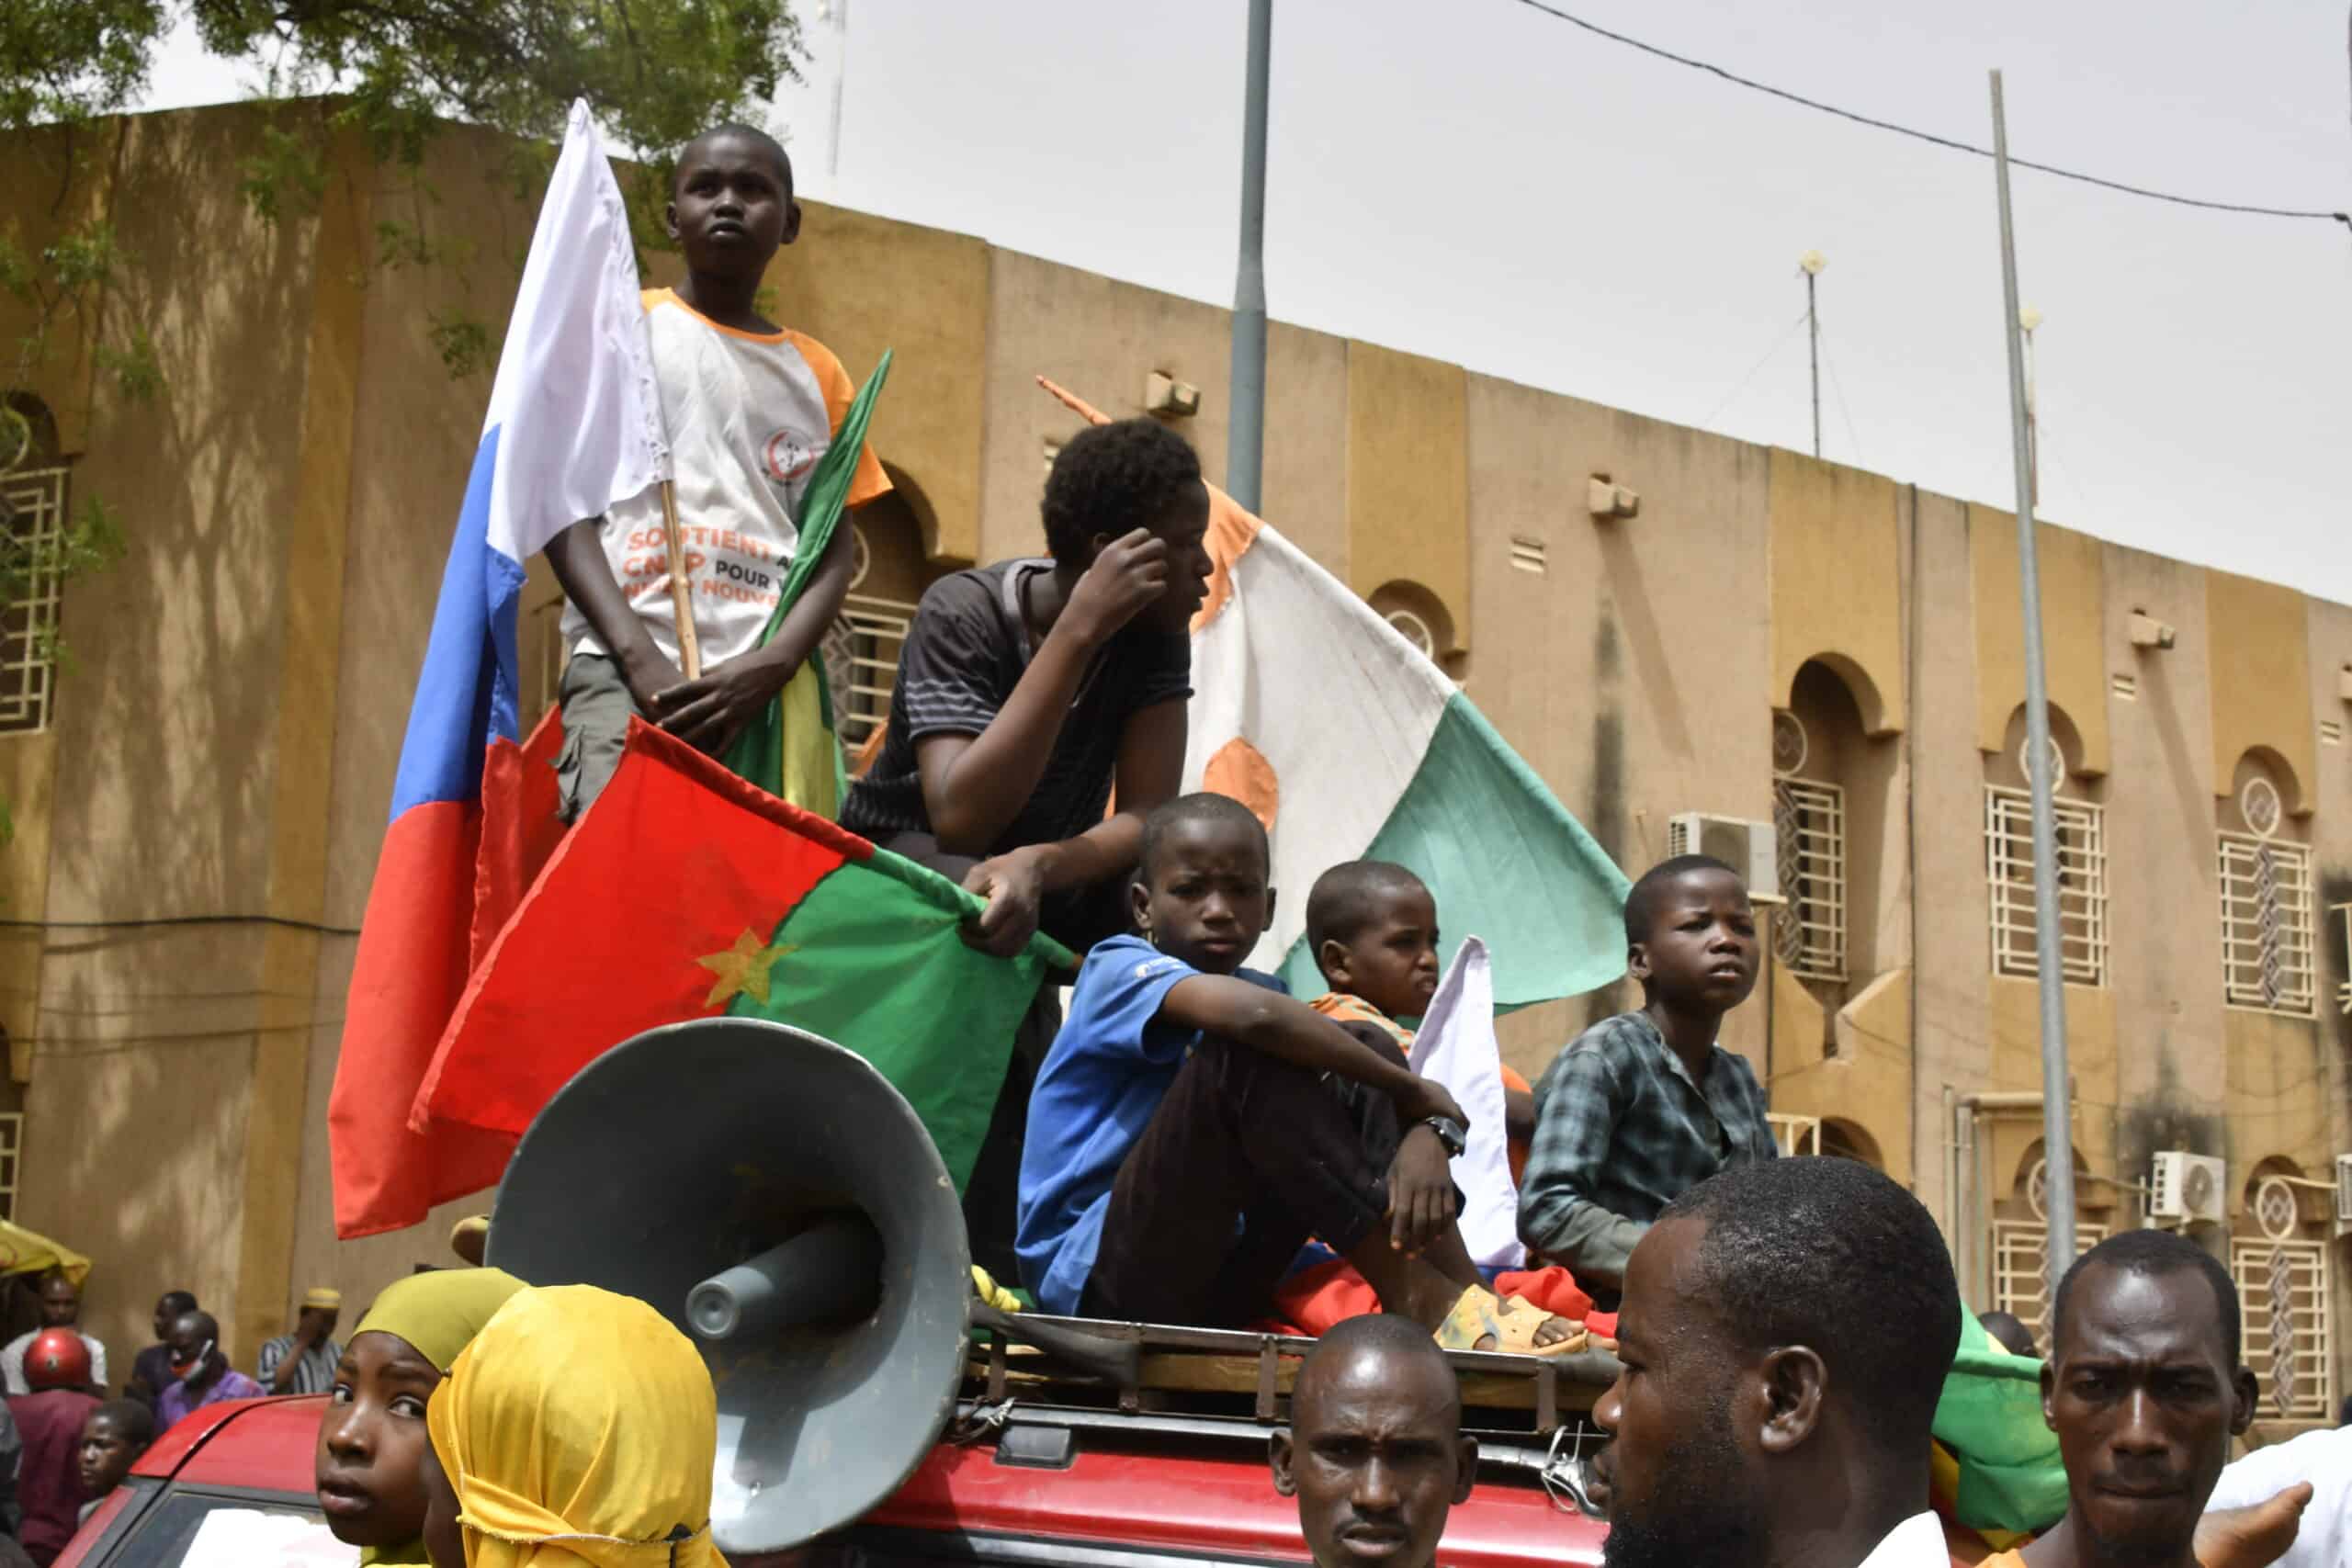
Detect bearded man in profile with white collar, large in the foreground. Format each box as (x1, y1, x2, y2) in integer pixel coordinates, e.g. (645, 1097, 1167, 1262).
(1592, 1159, 1959, 1568)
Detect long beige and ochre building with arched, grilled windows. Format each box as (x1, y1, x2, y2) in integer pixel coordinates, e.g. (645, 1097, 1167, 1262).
(0, 108, 2352, 1420)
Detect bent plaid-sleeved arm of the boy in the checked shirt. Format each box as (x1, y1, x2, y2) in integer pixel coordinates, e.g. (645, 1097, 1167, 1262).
(1520, 1046, 1649, 1288)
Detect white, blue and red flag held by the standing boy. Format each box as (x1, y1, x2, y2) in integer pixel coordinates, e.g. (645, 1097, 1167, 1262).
(327, 104, 671, 1236)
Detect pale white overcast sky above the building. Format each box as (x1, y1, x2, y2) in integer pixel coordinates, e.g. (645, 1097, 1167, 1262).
(151, 0, 2352, 602)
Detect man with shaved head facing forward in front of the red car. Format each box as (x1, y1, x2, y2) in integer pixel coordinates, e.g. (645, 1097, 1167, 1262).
(1270, 1314, 1477, 1568)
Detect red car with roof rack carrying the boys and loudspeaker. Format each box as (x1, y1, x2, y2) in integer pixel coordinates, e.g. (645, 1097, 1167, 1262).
(56, 1336, 1604, 1568)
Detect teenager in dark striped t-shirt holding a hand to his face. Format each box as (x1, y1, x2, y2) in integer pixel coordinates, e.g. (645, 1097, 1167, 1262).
(842, 419, 1209, 1279)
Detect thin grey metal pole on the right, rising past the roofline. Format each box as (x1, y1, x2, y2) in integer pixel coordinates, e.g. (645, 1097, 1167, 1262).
(1992, 71, 2075, 1288)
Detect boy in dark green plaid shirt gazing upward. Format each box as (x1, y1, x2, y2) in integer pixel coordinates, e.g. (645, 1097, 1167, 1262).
(1520, 856, 1781, 1309)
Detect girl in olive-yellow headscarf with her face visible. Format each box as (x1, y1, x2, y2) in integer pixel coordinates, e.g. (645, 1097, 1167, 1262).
(318, 1269, 522, 1565)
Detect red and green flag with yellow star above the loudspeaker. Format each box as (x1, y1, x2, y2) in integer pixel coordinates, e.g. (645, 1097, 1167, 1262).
(409, 722, 1075, 1185)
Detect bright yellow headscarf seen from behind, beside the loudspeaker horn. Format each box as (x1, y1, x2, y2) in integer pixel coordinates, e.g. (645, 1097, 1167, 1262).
(425, 1286, 727, 1568)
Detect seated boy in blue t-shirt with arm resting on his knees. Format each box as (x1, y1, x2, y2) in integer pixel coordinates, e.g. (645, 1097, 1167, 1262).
(1016, 795, 1580, 1354)
